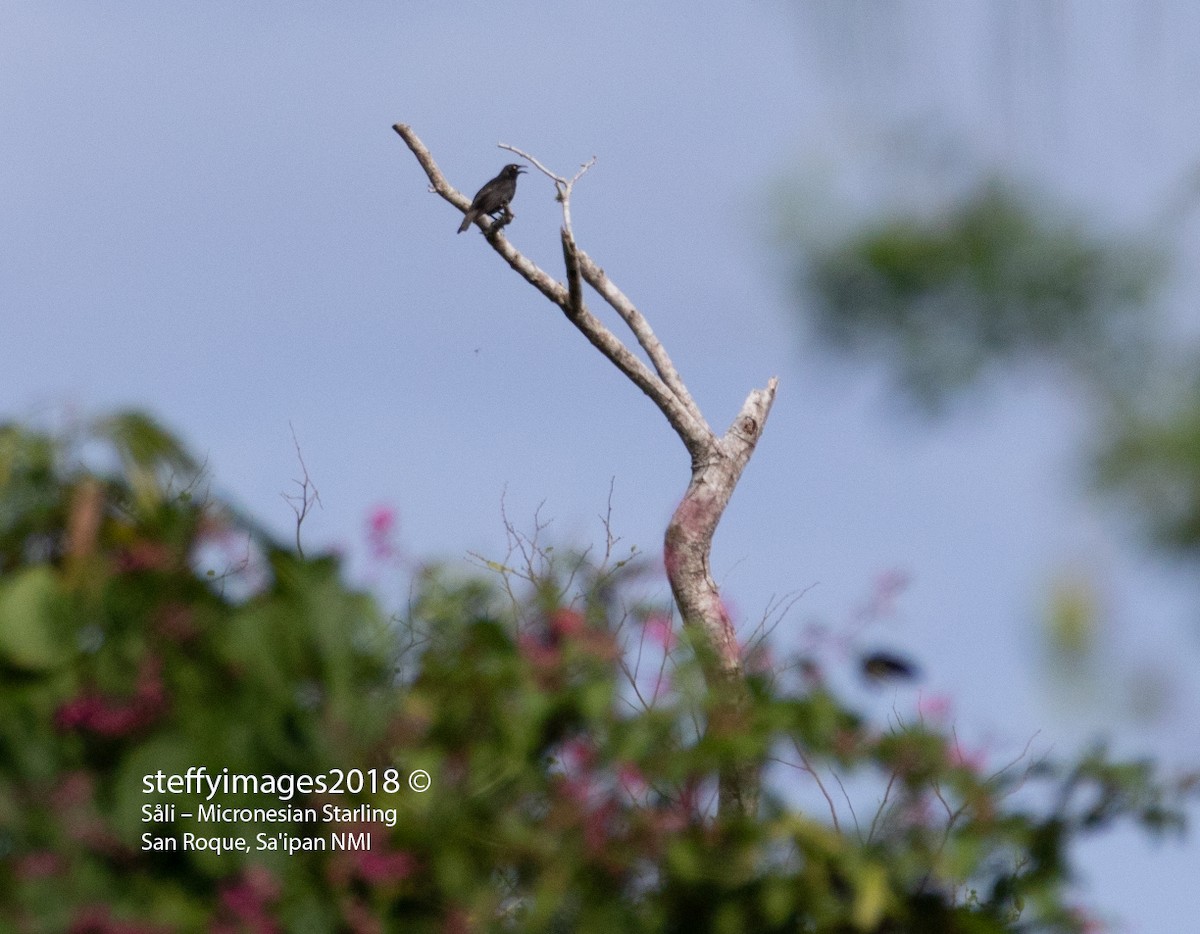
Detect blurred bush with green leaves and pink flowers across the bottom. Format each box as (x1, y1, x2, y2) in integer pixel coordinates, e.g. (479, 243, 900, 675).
(0, 414, 1200, 934)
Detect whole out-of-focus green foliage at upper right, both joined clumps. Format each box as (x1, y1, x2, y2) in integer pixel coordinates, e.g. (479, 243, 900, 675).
(786, 176, 1200, 566)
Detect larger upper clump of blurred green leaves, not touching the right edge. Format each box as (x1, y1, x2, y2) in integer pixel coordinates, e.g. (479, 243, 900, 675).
(797, 178, 1163, 409)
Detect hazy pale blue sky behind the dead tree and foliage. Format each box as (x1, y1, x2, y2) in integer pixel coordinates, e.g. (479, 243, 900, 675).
(0, 0, 1200, 932)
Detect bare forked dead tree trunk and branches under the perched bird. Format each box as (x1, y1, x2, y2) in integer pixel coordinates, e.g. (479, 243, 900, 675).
(392, 124, 778, 814)
